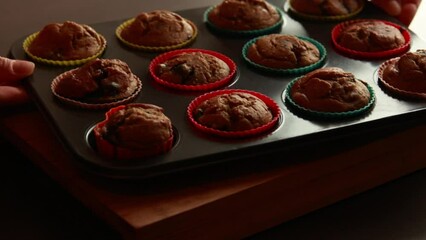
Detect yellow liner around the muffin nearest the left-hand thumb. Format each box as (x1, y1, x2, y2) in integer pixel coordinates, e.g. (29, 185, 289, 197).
(22, 32, 107, 67)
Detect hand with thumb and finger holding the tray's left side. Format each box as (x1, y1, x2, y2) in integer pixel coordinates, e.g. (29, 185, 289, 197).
(0, 56, 35, 107)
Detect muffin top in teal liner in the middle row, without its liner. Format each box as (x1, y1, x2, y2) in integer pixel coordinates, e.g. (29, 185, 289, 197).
(247, 34, 320, 69)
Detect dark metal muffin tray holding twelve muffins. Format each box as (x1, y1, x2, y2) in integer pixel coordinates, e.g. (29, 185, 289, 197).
(11, 4, 426, 179)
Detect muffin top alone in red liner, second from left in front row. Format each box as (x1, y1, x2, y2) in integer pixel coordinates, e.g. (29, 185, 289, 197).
(194, 92, 273, 131)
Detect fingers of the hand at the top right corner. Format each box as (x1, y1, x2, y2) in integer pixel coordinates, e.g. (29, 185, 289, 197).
(371, 0, 421, 26)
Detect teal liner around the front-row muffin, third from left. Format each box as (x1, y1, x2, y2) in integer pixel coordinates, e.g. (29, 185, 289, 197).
(284, 77, 376, 120)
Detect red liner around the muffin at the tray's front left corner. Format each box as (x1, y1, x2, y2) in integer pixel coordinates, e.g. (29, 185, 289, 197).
(93, 104, 174, 160)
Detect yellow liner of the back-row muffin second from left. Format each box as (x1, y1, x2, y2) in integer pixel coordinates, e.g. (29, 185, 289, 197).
(115, 18, 198, 52)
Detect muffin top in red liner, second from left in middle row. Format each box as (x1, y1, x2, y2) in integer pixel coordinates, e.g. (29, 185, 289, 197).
(156, 52, 230, 85)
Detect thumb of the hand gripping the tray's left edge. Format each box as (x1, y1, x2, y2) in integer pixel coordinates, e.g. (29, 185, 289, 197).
(0, 57, 35, 83)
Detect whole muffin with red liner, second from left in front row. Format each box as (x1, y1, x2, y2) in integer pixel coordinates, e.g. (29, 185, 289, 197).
(188, 89, 280, 137)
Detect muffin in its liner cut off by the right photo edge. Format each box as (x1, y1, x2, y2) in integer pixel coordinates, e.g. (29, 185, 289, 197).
(379, 49, 426, 99)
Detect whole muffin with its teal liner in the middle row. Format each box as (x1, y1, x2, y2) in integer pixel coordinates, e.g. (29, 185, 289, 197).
(243, 34, 325, 73)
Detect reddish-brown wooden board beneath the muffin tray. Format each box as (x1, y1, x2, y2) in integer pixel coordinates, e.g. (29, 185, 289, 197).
(0, 109, 426, 239)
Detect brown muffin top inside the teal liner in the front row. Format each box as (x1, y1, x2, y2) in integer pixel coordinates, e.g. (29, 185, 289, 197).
(290, 67, 370, 112)
